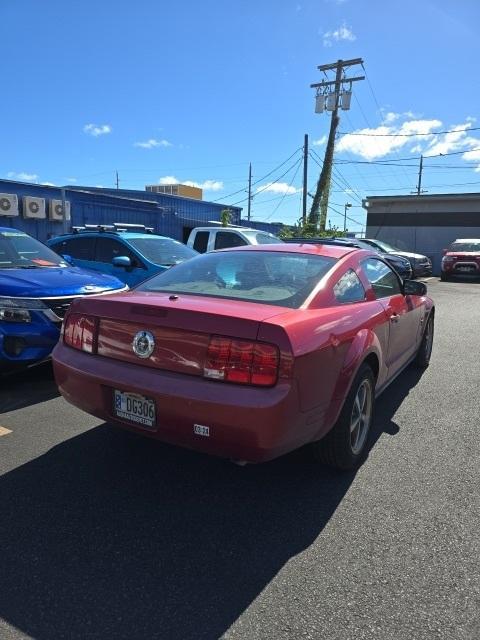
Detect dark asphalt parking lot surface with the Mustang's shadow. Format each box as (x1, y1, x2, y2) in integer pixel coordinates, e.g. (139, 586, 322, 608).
(0, 279, 480, 640)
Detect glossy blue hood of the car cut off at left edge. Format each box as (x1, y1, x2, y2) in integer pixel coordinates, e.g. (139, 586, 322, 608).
(0, 267, 125, 298)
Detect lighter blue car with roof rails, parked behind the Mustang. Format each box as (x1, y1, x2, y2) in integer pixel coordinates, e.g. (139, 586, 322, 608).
(48, 224, 198, 287)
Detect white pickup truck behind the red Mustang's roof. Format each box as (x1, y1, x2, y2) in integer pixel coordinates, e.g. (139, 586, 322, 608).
(187, 227, 282, 253)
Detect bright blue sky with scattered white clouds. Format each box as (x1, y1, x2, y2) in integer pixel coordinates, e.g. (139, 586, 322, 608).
(0, 0, 480, 230)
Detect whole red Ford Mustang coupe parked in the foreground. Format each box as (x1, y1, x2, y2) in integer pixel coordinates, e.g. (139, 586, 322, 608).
(53, 244, 435, 469)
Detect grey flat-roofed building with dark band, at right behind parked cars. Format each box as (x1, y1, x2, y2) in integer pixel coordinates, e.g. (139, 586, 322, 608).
(363, 193, 480, 275)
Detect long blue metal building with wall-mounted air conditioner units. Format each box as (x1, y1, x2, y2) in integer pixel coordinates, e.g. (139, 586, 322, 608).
(0, 180, 248, 242)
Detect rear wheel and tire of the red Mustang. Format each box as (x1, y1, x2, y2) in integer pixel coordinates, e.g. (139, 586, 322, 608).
(311, 364, 375, 471)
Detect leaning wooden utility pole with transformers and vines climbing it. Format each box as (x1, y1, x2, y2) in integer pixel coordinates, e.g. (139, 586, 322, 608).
(308, 58, 365, 231)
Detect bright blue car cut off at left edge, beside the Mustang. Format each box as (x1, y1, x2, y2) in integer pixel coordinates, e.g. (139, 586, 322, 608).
(0, 227, 127, 372)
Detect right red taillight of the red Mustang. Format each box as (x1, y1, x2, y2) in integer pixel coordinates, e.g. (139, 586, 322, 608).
(203, 336, 280, 387)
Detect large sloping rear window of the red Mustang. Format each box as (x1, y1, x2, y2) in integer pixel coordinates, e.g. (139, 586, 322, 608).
(137, 251, 336, 308)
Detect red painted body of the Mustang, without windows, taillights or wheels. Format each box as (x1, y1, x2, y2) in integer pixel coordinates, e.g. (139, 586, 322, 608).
(53, 244, 433, 462)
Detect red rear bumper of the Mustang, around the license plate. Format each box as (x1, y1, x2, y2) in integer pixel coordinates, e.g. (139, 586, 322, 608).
(53, 343, 308, 462)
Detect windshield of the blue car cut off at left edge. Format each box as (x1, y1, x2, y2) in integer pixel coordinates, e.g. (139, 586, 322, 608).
(0, 229, 68, 269)
